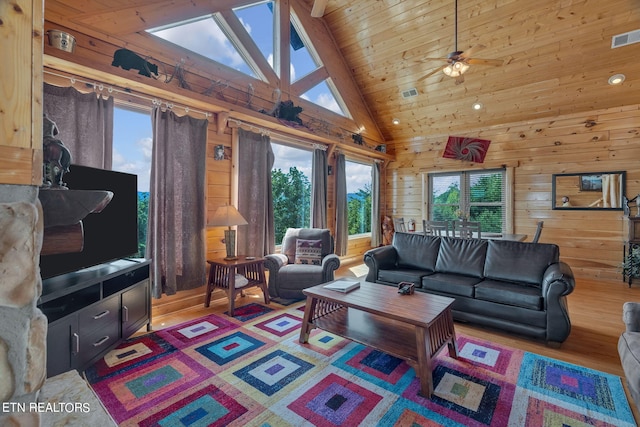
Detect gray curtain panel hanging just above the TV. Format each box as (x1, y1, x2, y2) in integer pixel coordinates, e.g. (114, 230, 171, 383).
(43, 83, 113, 170)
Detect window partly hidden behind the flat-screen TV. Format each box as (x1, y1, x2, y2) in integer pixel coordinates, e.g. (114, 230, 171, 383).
(111, 107, 153, 257)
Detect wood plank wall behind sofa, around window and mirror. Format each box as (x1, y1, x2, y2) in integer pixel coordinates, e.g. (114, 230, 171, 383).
(382, 105, 640, 280)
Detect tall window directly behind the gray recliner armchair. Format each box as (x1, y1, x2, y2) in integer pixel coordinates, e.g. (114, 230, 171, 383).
(271, 142, 312, 245)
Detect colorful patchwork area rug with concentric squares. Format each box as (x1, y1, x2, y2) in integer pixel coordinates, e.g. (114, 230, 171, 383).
(85, 303, 636, 427)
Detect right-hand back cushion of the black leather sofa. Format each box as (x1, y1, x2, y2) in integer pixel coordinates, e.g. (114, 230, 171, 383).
(484, 240, 560, 286)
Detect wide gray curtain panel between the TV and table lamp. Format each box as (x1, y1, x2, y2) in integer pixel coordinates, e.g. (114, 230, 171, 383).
(146, 107, 208, 298)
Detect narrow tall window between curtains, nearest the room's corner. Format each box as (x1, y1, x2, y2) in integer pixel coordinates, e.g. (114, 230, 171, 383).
(345, 161, 372, 236)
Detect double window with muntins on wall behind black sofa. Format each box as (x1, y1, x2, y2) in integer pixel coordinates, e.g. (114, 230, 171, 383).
(428, 169, 507, 233)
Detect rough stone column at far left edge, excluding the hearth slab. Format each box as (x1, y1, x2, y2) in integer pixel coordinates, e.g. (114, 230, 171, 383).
(0, 185, 47, 426)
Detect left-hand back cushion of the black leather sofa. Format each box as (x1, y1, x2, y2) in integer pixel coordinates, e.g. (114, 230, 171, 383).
(393, 233, 440, 271)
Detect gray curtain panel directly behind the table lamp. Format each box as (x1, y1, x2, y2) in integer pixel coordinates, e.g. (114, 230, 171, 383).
(237, 128, 276, 257)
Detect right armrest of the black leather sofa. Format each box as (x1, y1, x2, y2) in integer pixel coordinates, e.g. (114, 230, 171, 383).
(542, 261, 576, 345)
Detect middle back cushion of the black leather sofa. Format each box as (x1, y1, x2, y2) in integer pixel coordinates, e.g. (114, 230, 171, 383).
(436, 237, 487, 278)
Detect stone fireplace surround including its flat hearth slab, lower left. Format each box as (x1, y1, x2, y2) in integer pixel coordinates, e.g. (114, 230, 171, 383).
(0, 184, 116, 427)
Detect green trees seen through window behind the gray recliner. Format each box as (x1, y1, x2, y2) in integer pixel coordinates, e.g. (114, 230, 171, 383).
(271, 167, 311, 244)
